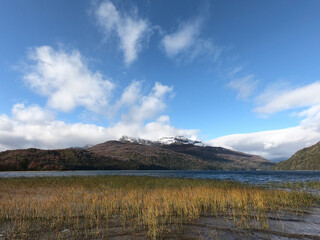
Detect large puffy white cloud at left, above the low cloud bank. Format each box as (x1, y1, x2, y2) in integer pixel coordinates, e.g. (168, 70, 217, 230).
(24, 46, 114, 113)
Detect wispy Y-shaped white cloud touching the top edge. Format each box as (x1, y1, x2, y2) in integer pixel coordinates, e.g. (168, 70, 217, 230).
(95, 1, 150, 65)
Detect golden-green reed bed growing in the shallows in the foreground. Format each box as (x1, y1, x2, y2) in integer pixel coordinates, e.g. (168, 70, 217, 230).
(0, 176, 318, 239)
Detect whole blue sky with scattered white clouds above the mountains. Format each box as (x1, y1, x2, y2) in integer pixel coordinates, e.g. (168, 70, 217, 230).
(0, 0, 320, 161)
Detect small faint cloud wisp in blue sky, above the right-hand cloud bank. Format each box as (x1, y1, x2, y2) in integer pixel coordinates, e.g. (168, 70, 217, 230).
(228, 74, 258, 99)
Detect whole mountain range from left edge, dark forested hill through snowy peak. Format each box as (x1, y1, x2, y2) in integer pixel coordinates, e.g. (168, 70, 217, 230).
(0, 137, 273, 171)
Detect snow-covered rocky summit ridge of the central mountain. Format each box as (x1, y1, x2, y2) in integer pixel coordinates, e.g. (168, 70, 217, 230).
(119, 136, 205, 147)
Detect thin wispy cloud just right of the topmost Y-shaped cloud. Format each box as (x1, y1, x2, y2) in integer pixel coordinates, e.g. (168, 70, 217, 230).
(161, 17, 222, 62)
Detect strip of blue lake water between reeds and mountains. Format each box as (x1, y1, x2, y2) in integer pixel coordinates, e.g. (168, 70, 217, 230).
(0, 170, 320, 184)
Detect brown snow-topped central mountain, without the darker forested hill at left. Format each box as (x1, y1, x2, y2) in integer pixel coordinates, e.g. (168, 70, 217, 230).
(88, 137, 273, 170)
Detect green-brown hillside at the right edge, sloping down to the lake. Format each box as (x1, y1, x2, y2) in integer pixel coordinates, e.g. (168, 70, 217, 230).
(274, 142, 320, 170)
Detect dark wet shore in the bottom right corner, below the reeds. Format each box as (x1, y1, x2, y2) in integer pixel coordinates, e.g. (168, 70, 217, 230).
(181, 208, 320, 240)
